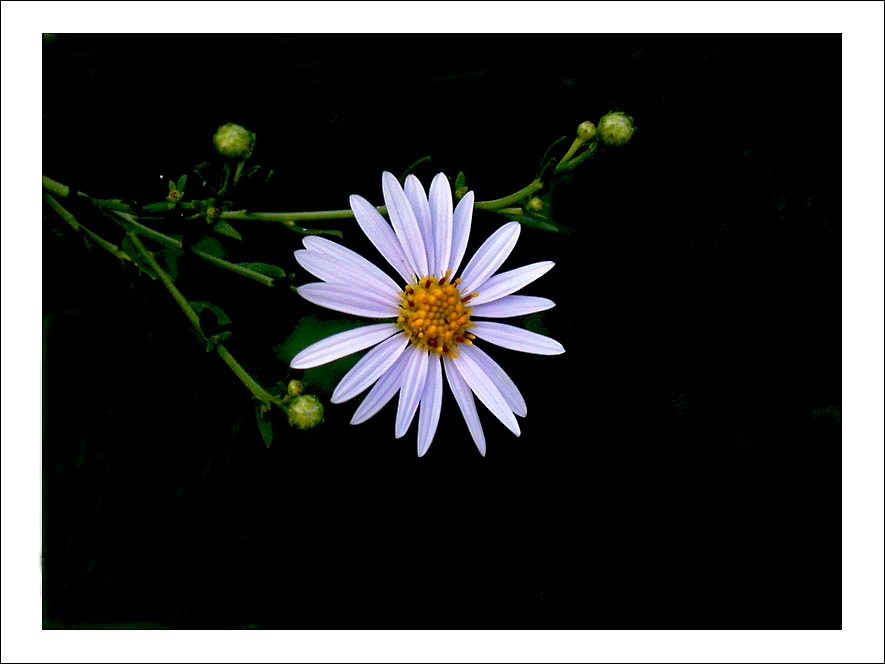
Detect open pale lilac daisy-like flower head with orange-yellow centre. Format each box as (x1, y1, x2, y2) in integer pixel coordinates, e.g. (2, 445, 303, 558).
(291, 172, 565, 456)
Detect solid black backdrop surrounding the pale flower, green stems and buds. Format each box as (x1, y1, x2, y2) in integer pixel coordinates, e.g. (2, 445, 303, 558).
(43, 35, 841, 629)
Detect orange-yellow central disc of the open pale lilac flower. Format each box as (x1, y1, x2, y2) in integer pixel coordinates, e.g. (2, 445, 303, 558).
(396, 271, 479, 357)
